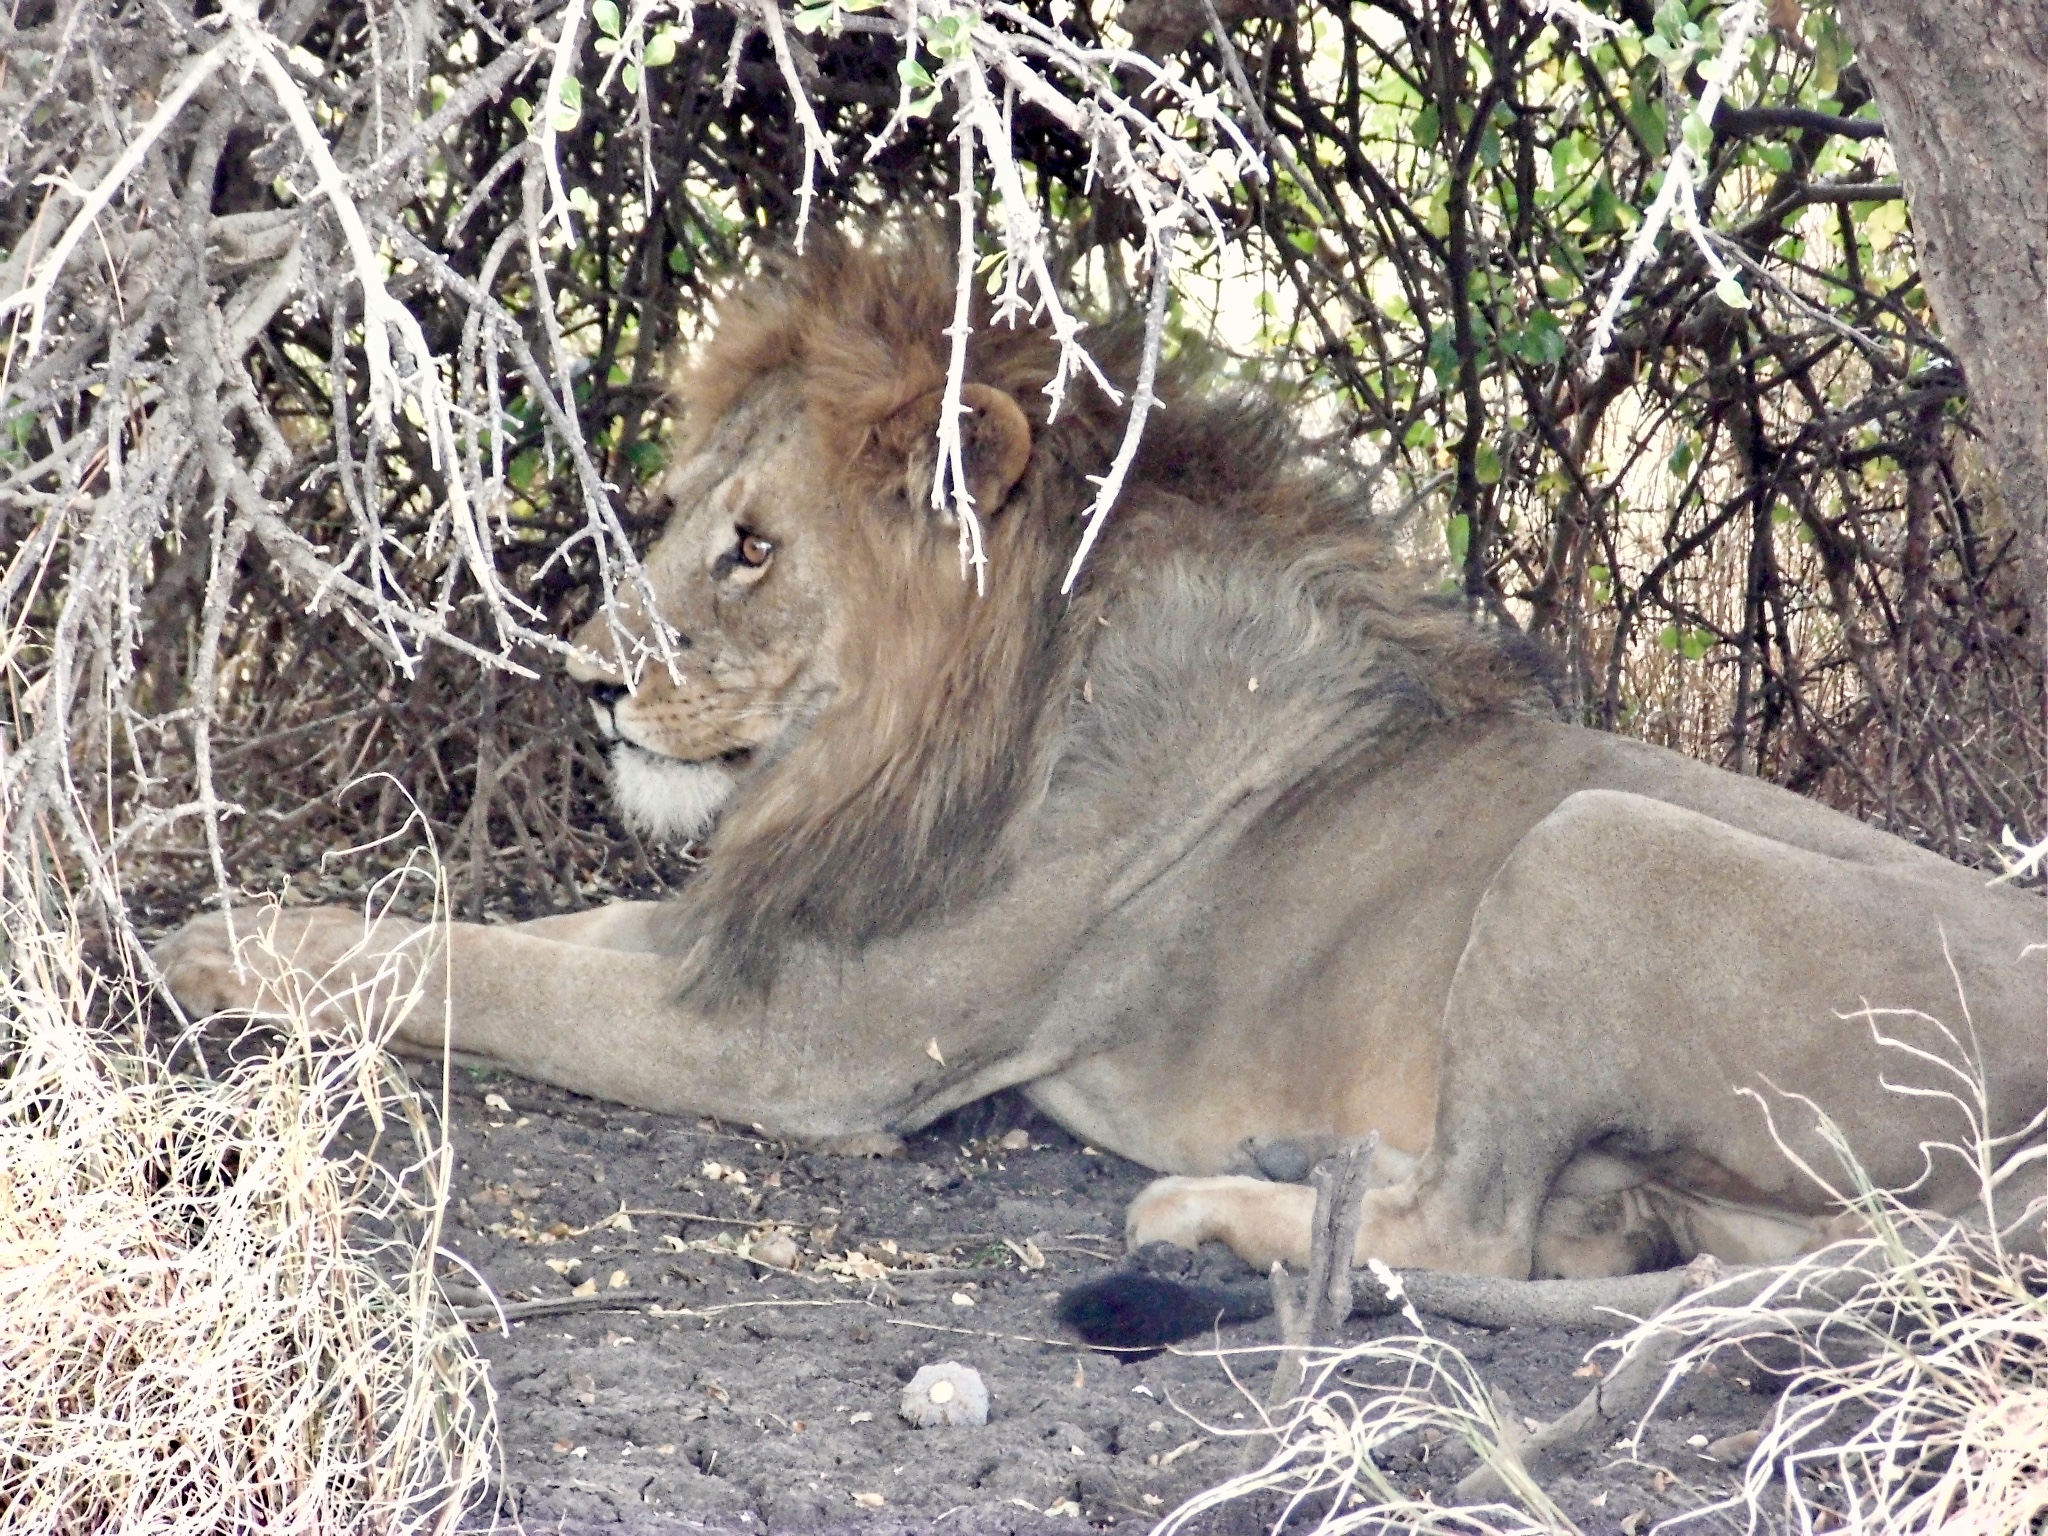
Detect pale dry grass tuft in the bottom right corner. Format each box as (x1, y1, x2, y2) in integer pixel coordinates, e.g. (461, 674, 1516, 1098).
(1642, 1010, 2048, 1536)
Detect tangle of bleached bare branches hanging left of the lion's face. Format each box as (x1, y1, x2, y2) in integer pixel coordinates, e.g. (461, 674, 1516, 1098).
(0, 0, 637, 911)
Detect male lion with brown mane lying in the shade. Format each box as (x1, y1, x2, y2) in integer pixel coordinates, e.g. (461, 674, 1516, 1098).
(160, 242, 2044, 1318)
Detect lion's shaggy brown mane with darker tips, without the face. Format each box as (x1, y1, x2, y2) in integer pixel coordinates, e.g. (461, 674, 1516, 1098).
(676, 229, 1534, 1001)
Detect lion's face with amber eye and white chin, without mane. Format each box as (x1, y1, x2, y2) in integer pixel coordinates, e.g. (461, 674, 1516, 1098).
(569, 379, 844, 840)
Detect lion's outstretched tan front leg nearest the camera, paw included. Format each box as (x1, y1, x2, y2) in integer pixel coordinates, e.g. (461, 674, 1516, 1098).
(158, 903, 1028, 1139)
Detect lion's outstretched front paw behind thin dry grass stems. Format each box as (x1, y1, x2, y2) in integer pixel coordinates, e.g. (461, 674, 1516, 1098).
(154, 907, 418, 1018)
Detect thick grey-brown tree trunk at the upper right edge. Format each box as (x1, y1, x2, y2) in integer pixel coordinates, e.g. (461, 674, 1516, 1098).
(1841, 0, 2048, 573)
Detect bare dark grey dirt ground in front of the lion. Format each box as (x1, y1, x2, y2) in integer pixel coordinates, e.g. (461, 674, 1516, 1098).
(385, 1071, 1774, 1536)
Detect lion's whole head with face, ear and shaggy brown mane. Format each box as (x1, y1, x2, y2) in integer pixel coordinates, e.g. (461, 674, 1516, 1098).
(571, 228, 1528, 995)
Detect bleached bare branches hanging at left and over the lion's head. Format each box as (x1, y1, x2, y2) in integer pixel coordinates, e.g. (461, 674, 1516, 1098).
(0, 0, 1264, 909)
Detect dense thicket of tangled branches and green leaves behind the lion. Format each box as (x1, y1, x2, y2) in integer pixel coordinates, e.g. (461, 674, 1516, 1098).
(0, 0, 2044, 921)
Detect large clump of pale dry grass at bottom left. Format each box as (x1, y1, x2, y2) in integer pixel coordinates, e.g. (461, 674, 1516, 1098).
(0, 856, 496, 1536)
